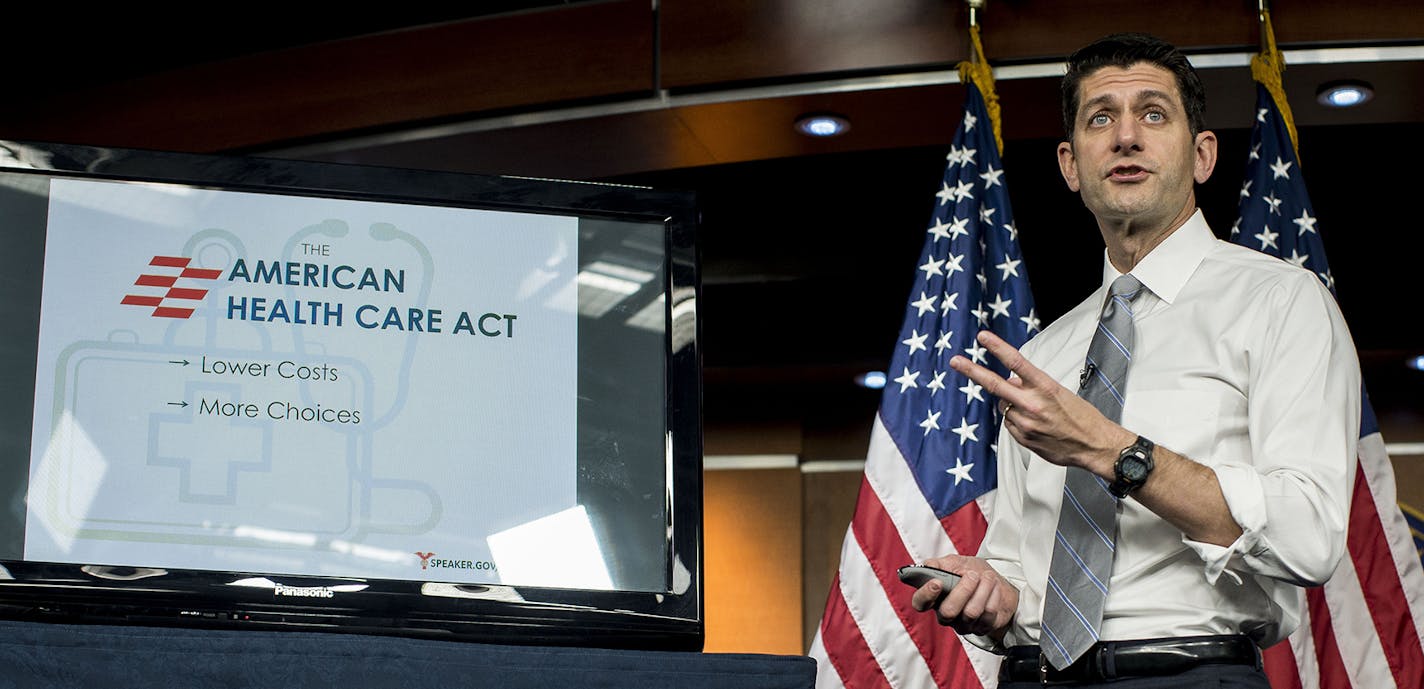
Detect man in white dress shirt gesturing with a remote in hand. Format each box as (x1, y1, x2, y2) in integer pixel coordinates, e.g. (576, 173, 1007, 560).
(913, 34, 1360, 689)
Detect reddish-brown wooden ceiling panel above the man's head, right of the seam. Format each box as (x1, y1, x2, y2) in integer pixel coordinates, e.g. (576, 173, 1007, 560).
(659, 0, 1424, 90)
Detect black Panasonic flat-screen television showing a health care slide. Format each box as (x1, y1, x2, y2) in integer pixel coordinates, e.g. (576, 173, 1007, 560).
(0, 141, 703, 649)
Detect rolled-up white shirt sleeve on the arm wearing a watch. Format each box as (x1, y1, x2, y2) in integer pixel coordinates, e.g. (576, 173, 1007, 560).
(1183, 272, 1361, 585)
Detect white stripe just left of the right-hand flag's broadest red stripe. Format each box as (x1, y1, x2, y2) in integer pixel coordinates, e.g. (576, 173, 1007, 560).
(1317, 546, 1397, 689)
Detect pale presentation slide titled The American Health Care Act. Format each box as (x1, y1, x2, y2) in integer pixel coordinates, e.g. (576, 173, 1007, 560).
(24, 179, 587, 585)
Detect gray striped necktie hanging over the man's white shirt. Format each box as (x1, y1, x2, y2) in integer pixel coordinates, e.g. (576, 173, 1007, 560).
(1040, 275, 1142, 669)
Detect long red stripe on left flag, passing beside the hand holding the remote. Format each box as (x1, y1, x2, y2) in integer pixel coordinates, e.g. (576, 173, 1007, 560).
(850, 480, 981, 688)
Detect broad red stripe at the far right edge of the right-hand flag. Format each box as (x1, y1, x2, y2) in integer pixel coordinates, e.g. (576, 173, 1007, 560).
(1347, 463, 1424, 689)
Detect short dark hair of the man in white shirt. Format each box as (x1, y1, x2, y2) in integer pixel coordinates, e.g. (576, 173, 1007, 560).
(1062, 33, 1206, 141)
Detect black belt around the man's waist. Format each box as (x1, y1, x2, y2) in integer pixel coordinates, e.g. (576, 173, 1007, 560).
(998, 635, 1260, 685)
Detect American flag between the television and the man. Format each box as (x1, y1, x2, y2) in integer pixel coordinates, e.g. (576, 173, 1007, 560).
(810, 81, 1040, 689)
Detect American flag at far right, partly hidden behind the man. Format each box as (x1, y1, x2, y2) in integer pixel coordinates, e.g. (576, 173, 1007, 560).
(1232, 79, 1424, 689)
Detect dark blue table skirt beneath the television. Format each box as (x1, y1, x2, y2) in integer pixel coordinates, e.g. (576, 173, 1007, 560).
(0, 621, 816, 689)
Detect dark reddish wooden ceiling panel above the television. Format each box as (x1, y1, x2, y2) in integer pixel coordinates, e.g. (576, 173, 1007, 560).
(0, 0, 654, 151)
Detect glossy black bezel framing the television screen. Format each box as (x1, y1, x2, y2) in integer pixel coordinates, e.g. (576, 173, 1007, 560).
(0, 140, 703, 651)
